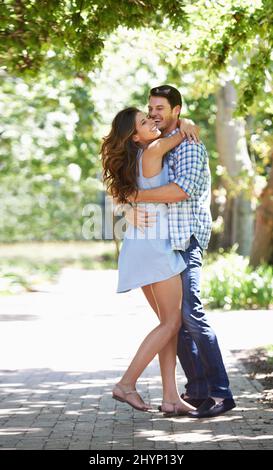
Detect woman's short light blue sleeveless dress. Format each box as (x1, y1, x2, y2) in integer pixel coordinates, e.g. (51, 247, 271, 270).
(117, 150, 186, 293)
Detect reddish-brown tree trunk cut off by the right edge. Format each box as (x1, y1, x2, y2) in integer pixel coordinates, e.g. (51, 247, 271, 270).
(250, 160, 273, 267)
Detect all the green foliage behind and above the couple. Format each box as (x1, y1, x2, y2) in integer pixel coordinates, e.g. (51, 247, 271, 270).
(0, 0, 273, 308)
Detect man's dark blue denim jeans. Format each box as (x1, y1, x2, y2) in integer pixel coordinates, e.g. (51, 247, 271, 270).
(177, 236, 232, 398)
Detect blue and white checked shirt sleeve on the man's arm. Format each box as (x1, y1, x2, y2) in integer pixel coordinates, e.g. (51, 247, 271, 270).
(173, 142, 206, 196)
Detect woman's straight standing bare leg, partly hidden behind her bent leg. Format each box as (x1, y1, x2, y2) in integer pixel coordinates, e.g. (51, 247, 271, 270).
(142, 286, 180, 403)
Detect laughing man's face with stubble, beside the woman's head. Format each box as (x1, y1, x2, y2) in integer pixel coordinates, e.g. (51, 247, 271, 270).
(148, 96, 180, 131)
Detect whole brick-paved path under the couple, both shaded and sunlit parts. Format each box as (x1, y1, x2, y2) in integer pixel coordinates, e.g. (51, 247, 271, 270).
(0, 269, 273, 450)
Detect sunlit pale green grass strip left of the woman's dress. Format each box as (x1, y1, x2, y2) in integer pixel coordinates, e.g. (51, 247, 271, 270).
(0, 242, 116, 295)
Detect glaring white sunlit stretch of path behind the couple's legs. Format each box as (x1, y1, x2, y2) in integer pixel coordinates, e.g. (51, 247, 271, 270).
(0, 269, 273, 371)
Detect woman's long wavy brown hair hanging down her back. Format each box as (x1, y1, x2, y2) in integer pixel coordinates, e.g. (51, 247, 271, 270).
(101, 107, 139, 203)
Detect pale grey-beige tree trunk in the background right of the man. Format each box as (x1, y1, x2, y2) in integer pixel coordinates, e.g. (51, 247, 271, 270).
(216, 82, 254, 255)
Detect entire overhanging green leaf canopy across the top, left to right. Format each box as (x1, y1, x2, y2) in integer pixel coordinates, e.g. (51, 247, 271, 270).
(0, 0, 273, 112)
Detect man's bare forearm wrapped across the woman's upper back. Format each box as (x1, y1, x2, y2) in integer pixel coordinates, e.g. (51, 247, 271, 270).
(132, 183, 189, 203)
